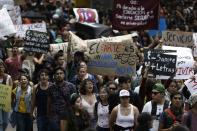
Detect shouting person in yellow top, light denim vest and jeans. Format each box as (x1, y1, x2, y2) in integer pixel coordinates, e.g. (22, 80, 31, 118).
(12, 74, 33, 131)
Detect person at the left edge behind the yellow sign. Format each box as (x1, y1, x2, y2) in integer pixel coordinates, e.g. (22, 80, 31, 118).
(0, 59, 12, 131)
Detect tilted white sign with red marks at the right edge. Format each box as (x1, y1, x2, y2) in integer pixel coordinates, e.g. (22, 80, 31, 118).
(184, 75, 197, 94)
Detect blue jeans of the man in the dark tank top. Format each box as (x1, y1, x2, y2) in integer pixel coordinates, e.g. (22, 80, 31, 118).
(37, 116, 49, 131)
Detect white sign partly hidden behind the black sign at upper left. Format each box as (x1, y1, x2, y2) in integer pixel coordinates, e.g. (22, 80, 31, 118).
(15, 23, 47, 38)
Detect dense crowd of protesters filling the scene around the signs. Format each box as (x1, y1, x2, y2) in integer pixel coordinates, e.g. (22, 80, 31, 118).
(0, 0, 197, 131)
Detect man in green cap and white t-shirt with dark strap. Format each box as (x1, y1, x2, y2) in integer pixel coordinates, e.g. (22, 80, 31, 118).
(142, 83, 169, 131)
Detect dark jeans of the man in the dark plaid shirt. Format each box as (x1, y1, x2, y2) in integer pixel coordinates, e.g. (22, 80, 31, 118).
(48, 119, 60, 131)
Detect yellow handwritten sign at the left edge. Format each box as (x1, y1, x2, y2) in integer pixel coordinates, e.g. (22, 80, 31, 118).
(0, 84, 12, 112)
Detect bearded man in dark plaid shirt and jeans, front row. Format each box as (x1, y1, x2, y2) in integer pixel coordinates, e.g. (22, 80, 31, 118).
(47, 67, 76, 131)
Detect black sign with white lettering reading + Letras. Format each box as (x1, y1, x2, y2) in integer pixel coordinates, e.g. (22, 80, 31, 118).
(144, 49, 176, 76)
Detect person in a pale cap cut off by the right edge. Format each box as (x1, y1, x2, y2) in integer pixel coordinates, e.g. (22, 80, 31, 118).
(182, 94, 197, 131)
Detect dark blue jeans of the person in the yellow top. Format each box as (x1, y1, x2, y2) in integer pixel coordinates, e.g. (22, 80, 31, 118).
(16, 112, 33, 131)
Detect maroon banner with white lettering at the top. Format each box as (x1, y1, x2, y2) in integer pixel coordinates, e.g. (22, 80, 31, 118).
(112, 0, 160, 30)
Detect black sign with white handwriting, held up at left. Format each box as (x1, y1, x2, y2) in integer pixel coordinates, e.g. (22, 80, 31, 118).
(24, 30, 50, 54)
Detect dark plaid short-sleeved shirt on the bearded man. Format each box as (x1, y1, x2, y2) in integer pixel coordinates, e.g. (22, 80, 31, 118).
(49, 81, 76, 118)
